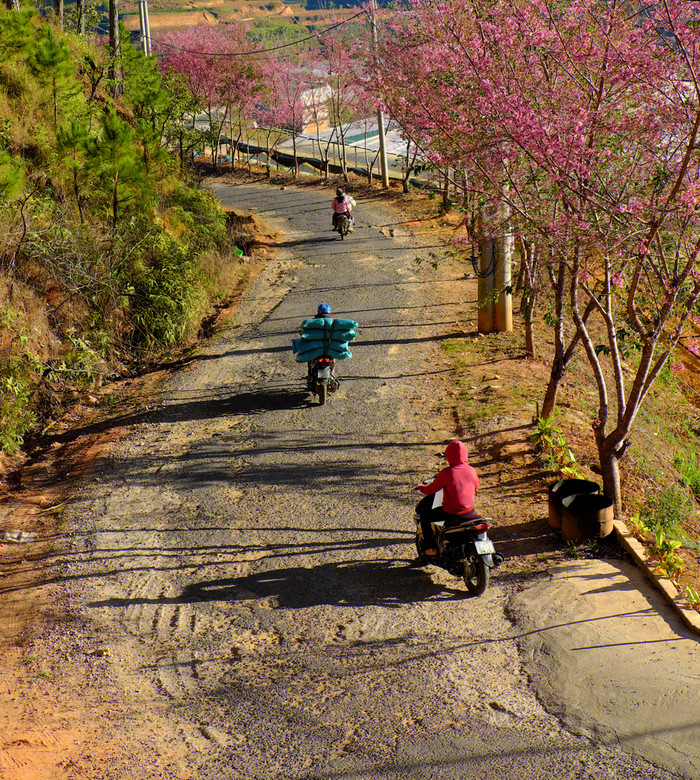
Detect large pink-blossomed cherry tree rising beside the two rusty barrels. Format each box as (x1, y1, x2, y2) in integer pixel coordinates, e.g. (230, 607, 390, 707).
(375, 0, 700, 513)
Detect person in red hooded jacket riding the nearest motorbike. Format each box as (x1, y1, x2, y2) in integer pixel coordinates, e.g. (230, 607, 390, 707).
(417, 440, 479, 556)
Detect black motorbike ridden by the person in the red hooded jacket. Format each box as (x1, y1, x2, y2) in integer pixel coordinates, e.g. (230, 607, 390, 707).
(415, 488, 504, 596)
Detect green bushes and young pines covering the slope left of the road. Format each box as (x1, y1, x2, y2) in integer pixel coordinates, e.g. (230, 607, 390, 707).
(0, 6, 250, 452)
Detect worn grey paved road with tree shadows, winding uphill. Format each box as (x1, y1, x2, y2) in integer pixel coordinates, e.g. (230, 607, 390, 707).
(53, 185, 691, 780)
